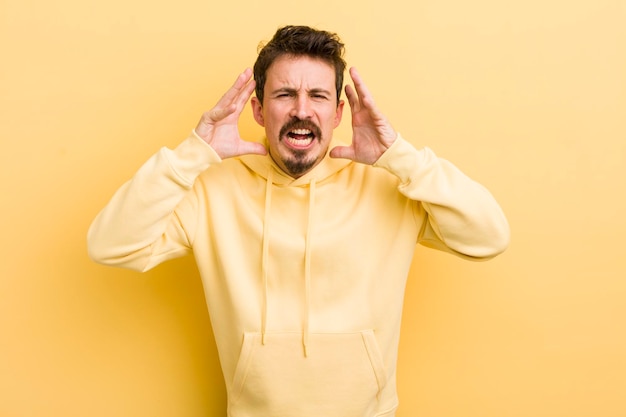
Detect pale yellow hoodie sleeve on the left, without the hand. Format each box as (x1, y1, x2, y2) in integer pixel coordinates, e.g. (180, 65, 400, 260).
(87, 133, 221, 271)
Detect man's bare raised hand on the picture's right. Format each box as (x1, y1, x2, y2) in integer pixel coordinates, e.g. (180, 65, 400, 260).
(330, 68, 397, 165)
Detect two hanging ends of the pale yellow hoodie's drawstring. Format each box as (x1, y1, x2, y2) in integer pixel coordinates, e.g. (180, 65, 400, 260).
(261, 169, 315, 357)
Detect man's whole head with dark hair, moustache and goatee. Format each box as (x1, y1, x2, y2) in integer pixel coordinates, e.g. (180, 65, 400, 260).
(252, 26, 346, 178)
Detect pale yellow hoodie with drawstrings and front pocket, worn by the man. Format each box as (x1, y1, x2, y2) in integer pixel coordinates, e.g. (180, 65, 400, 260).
(88, 134, 509, 417)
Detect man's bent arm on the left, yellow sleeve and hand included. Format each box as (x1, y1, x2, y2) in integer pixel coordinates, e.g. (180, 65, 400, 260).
(87, 69, 266, 271)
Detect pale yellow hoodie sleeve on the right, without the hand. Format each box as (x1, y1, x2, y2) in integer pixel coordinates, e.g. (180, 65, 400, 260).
(374, 136, 510, 260)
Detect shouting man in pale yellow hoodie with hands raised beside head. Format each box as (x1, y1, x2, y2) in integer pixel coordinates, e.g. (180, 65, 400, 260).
(88, 26, 509, 417)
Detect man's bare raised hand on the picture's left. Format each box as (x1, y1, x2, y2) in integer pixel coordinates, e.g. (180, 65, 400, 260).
(195, 68, 267, 159)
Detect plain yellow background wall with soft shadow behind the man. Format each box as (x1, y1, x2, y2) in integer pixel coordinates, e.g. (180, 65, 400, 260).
(0, 0, 626, 417)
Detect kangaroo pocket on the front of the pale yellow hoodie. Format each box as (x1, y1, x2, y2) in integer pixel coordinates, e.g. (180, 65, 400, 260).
(228, 330, 388, 417)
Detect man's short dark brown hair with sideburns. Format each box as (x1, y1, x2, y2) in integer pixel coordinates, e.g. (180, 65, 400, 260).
(254, 26, 346, 104)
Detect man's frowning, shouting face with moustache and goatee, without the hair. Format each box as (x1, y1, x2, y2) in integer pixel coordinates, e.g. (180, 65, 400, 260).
(252, 56, 344, 178)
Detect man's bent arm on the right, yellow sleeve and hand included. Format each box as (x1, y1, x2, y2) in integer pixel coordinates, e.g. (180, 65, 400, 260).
(330, 68, 510, 259)
